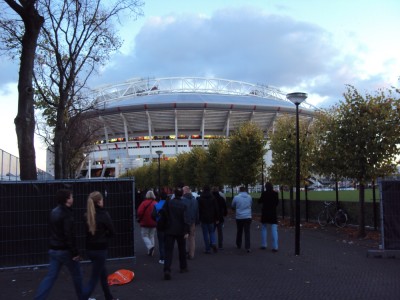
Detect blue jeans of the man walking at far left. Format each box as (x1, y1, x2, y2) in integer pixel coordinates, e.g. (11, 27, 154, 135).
(34, 249, 84, 300)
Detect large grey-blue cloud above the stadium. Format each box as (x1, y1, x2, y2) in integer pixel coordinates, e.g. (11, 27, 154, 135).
(92, 8, 374, 107)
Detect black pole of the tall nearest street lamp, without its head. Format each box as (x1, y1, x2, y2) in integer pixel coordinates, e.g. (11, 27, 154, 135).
(295, 103, 300, 255)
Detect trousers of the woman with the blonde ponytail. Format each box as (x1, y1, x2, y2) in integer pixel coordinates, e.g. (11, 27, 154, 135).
(83, 250, 114, 300)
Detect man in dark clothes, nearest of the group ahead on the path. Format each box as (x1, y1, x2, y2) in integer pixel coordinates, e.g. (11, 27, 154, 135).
(164, 188, 190, 280)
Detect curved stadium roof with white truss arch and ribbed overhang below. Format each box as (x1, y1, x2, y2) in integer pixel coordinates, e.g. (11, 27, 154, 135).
(87, 77, 315, 137)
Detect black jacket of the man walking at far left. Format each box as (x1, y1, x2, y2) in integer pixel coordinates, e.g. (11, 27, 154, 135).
(49, 204, 79, 257)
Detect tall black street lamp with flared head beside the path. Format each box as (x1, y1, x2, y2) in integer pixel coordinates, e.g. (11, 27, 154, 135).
(286, 93, 307, 255)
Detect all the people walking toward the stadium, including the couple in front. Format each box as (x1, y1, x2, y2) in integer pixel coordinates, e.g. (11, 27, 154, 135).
(34, 182, 278, 300)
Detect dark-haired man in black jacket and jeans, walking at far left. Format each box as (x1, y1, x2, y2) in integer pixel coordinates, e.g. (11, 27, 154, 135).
(34, 189, 82, 299)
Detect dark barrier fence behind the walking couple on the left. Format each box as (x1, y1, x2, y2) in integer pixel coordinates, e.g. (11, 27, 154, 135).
(0, 179, 135, 269)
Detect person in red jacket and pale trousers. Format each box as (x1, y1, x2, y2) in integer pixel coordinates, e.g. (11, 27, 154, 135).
(137, 190, 157, 256)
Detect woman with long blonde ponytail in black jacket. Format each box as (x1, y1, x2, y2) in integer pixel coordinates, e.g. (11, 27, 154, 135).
(83, 191, 115, 300)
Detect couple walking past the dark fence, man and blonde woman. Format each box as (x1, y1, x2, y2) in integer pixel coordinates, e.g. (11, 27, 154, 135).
(34, 189, 115, 300)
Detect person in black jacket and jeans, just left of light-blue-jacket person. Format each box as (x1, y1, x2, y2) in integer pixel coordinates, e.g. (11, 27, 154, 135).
(199, 186, 219, 254)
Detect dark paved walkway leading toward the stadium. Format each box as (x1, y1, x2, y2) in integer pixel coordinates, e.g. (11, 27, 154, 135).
(0, 219, 400, 300)
